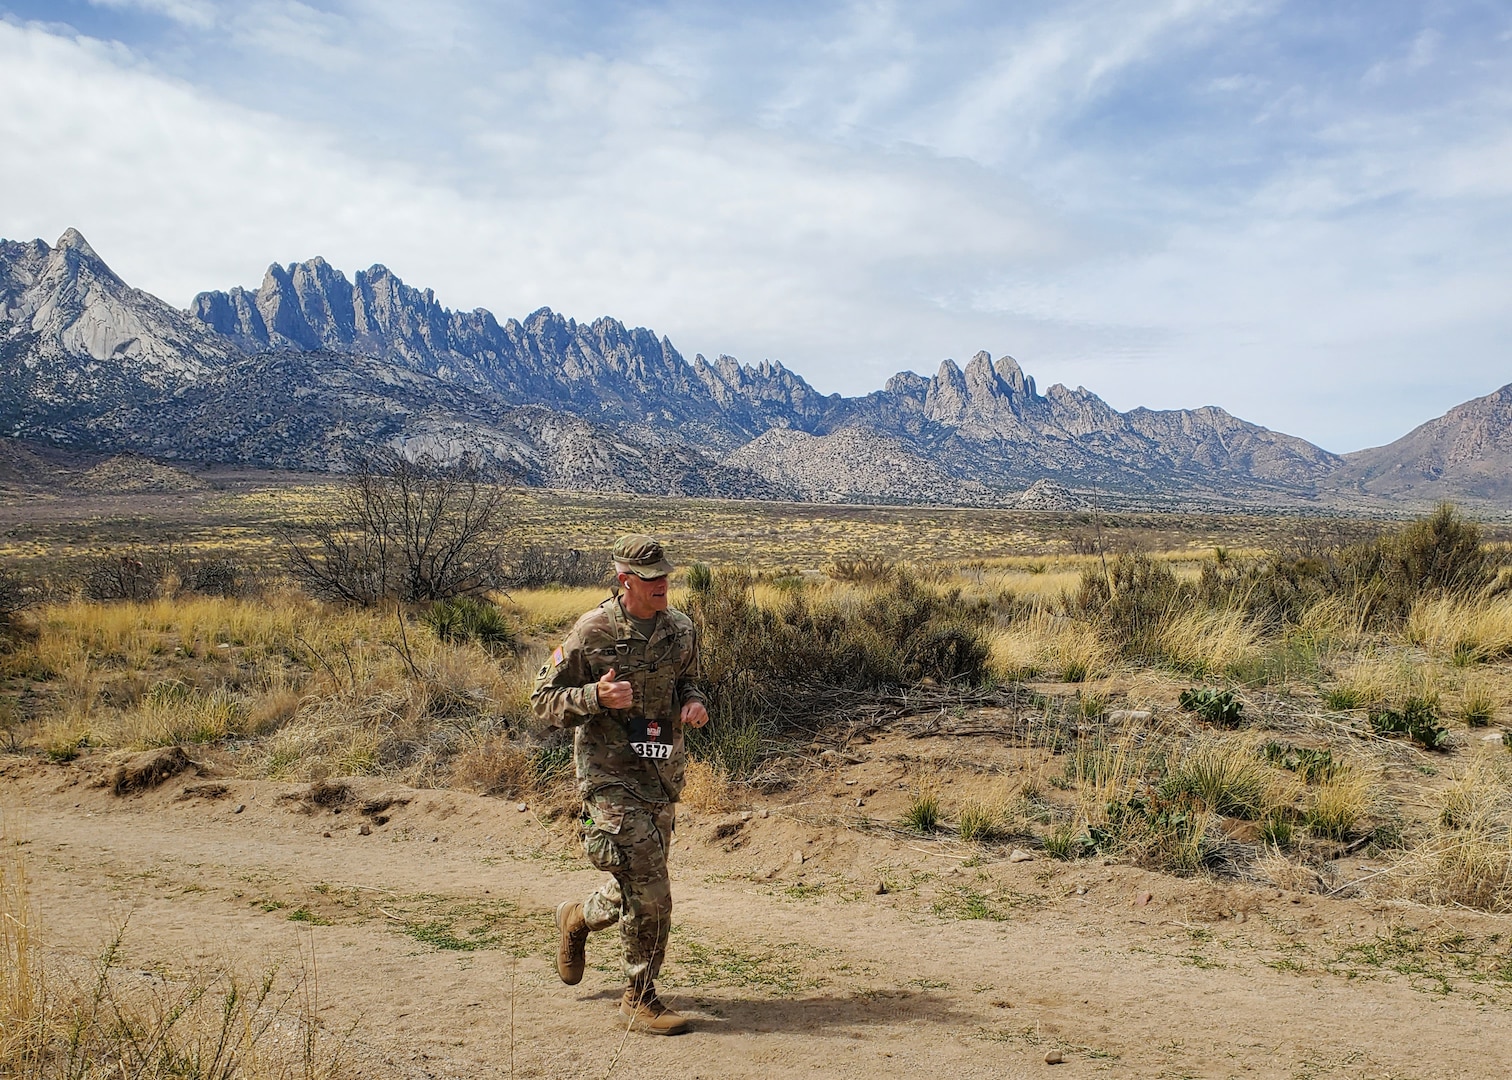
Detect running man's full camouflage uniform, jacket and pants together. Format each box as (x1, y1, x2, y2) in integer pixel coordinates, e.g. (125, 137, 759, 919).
(531, 597, 703, 988)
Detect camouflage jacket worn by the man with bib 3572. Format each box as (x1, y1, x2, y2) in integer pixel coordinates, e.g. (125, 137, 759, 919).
(531, 597, 703, 803)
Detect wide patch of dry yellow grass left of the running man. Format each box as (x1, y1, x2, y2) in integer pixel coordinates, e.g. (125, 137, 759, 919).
(11, 594, 544, 784)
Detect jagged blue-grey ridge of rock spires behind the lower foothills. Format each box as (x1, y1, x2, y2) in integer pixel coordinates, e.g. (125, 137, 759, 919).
(179, 243, 1340, 487)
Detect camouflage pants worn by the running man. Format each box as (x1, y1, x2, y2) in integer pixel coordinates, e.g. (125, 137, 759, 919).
(582, 793, 676, 989)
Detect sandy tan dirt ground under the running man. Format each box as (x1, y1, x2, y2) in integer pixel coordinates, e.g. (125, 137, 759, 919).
(0, 755, 1512, 1078)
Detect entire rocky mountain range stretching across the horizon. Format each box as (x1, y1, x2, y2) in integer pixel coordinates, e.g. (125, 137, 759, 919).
(0, 230, 1512, 505)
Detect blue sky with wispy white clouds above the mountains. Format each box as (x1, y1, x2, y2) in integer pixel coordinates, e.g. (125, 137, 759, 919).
(0, 0, 1512, 452)
